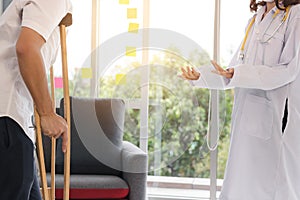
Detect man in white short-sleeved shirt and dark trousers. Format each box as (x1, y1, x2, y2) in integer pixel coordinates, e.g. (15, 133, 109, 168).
(0, 0, 71, 200)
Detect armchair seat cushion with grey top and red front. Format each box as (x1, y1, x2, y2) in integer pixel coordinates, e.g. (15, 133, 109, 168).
(47, 174, 129, 199)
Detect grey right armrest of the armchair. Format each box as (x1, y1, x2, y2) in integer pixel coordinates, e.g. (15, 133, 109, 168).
(122, 141, 148, 200)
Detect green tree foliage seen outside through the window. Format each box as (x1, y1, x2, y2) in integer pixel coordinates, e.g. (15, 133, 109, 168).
(57, 48, 233, 178)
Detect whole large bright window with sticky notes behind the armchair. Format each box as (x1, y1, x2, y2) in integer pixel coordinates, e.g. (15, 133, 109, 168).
(51, 0, 251, 198)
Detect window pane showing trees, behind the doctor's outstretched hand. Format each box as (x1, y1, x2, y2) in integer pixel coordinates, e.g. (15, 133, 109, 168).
(149, 0, 214, 178)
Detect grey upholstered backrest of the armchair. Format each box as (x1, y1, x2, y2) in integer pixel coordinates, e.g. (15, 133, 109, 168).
(56, 97, 125, 176)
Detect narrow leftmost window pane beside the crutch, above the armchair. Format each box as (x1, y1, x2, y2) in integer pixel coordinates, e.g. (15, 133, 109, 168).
(53, 1, 92, 105)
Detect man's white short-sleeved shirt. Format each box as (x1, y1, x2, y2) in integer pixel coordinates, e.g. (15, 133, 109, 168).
(0, 0, 71, 143)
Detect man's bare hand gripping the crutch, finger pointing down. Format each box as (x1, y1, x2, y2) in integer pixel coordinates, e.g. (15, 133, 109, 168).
(40, 113, 68, 153)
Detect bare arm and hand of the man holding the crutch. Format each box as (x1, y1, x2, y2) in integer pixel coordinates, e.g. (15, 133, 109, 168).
(16, 27, 68, 152)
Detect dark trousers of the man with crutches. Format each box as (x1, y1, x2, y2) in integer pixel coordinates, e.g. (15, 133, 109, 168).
(0, 117, 41, 200)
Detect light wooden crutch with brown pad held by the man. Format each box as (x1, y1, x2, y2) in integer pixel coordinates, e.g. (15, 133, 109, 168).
(34, 14, 72, 200)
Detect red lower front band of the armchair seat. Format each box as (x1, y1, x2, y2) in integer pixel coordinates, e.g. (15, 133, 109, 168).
(55, 188, 129, 199)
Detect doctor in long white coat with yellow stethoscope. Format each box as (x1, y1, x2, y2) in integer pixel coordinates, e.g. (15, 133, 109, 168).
(182, 0, 300, 200)
